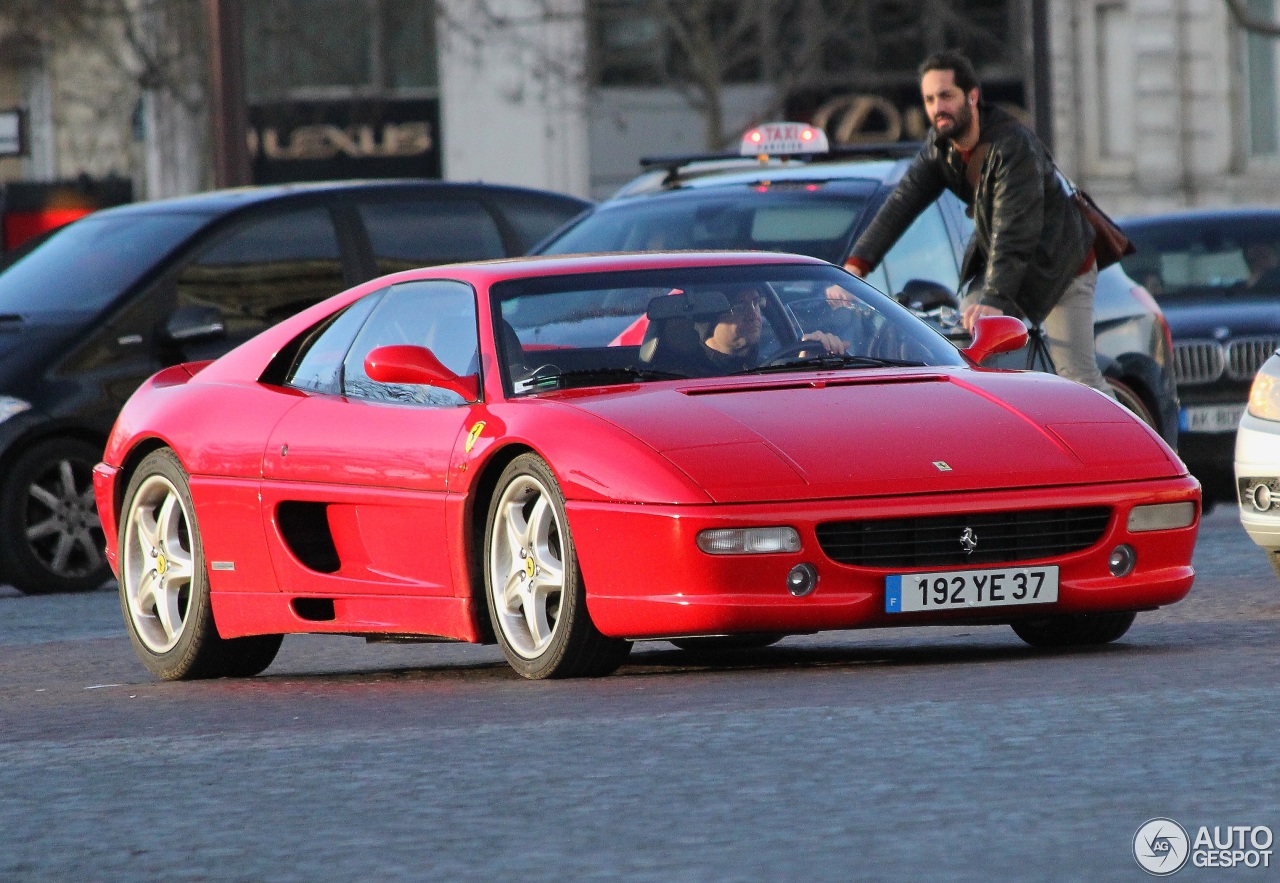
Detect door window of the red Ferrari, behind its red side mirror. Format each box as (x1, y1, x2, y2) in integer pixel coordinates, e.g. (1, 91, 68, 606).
(342, 280, 480, 407)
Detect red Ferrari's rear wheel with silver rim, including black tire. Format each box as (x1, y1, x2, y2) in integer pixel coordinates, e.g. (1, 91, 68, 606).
(118, 448, 283, 681)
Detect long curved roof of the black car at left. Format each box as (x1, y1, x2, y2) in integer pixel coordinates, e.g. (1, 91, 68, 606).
(85, 178, 591, 218)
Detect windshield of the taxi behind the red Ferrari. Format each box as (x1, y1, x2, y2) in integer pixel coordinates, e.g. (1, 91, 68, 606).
(540, 183, 867, 262)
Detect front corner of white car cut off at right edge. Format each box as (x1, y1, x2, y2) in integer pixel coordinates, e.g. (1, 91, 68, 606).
(1235, 352, 1280, 576)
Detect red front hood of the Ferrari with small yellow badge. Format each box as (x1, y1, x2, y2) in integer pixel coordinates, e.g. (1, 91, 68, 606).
(572, 370, 1185, 503)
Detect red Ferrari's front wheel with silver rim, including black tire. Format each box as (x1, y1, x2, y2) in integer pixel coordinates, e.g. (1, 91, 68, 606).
(483, 454, 631, 678)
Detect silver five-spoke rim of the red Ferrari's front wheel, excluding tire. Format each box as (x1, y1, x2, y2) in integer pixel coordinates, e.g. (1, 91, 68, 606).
(489, 475, 564, 659)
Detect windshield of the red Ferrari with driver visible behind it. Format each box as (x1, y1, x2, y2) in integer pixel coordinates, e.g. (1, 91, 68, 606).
(492, 264, 965, 395)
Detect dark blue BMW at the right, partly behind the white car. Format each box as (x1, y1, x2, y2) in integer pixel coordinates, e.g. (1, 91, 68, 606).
(1121, 209, 1280, 502)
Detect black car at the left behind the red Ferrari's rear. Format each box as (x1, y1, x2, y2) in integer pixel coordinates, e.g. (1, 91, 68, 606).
(0, 180, 590, 593)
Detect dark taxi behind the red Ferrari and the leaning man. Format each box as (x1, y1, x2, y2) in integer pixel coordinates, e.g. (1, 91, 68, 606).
(535, 145, 1178, 447)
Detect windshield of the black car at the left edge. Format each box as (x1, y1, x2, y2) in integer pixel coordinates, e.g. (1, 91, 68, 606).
(0, 212, 207, 315)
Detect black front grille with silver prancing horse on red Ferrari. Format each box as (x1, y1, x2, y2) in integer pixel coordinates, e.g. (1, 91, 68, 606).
(818, 505, 1111, 568)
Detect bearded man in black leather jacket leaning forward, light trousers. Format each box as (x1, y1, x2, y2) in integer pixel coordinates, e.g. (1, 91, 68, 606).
(845, 50, 1111, 395)
